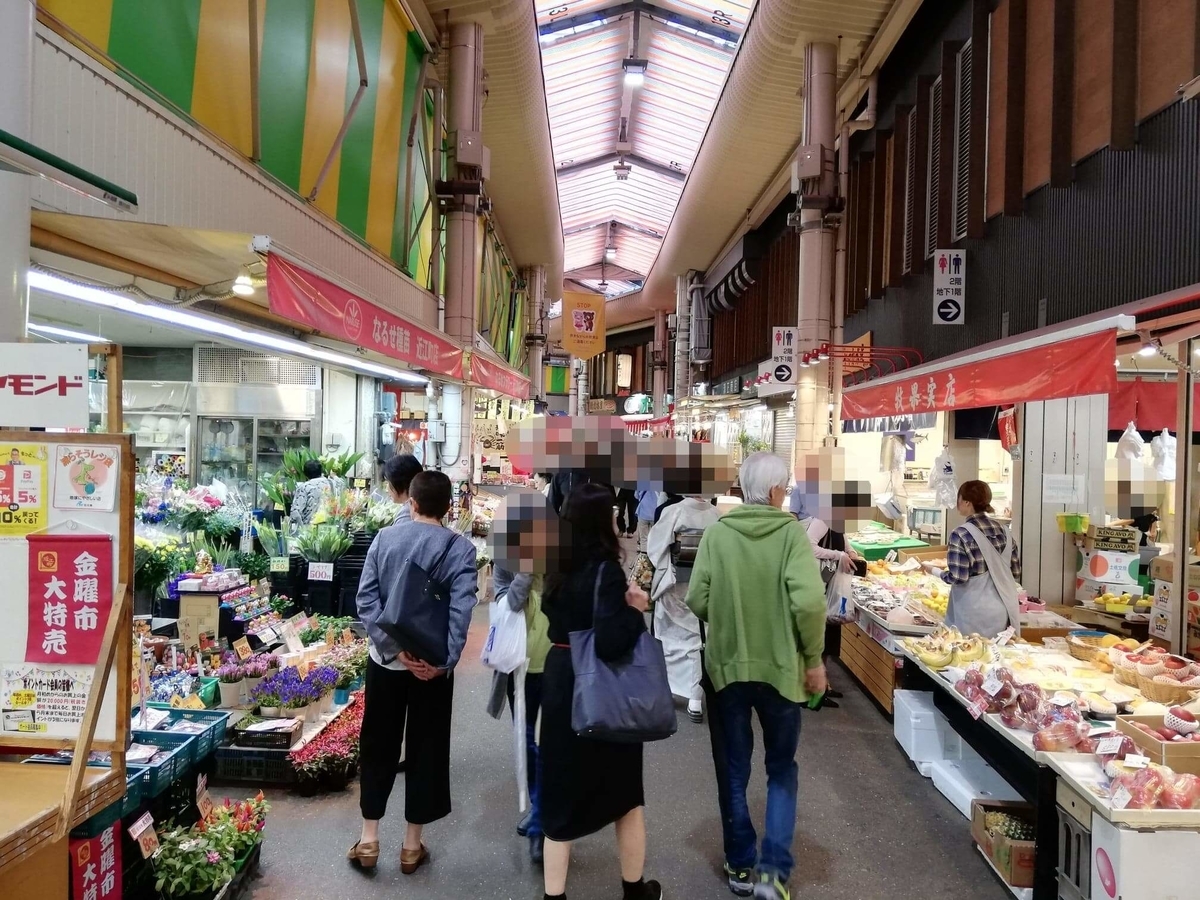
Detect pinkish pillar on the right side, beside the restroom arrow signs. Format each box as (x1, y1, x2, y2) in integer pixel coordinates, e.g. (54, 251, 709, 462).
(796, 43, 838, 450)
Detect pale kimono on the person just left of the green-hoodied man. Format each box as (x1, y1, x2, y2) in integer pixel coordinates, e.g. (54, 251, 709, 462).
(646, 497, 721, 724)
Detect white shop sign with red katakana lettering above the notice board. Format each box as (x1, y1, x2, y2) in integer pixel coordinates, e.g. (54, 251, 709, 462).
(0, 343, 88, 428)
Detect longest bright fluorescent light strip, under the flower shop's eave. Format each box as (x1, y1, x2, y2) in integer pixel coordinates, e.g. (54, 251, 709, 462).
(29, 270, 430, 384)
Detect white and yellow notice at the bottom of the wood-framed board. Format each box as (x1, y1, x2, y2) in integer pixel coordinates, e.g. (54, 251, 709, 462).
(0, 664, 95, 737)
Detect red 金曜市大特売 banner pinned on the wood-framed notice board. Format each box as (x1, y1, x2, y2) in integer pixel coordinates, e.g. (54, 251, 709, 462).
(25, 534, 113, 666)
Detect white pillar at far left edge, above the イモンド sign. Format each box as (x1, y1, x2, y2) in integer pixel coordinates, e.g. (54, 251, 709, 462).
(0, 0, 37, 343)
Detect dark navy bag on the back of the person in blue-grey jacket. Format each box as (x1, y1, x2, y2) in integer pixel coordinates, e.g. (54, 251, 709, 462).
(377, 534, 456, 668)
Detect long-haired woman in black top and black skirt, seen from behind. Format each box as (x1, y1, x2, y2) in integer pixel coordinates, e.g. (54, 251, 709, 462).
(541, 484, 662, 900)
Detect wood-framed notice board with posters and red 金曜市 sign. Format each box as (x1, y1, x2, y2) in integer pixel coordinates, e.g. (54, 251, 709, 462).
(0, 430, 133, 754)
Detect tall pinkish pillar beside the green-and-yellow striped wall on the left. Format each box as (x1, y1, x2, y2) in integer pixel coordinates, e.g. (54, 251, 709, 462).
(445, 23, 484, 347)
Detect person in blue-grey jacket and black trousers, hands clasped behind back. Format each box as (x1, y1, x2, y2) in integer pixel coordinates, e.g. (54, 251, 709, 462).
(347, 472, 479, 875)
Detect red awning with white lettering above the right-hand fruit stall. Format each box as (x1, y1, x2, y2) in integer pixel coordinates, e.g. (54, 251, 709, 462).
(841, 330, 1117, 419)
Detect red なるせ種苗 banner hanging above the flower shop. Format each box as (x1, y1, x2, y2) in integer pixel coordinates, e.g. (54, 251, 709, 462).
(266, 253, 462, 378)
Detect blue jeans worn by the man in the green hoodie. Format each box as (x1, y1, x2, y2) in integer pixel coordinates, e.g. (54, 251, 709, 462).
(716, 682, 800, 882)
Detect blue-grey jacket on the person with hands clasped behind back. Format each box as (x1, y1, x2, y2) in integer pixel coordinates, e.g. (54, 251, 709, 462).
(358, 521, 479, 670)
